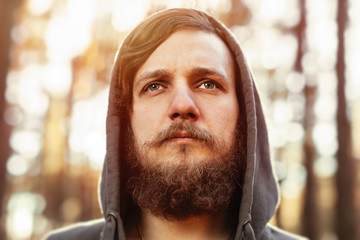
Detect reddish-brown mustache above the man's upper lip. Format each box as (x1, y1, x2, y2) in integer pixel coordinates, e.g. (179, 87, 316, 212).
(145, 122, 215, 147)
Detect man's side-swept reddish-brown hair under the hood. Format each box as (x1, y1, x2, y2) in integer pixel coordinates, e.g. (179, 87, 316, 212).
(113, 8, 237, 114)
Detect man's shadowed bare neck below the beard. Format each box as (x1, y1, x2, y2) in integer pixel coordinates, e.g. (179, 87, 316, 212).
(138, 211, 232, 240)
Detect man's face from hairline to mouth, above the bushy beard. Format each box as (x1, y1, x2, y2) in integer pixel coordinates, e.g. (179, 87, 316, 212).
(131, 30, 239, 166)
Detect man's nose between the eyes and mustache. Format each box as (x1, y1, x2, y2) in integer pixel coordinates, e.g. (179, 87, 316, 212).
(169, 87, 200, 121)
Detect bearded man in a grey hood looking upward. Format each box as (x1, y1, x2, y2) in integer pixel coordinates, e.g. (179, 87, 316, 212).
(45, 9, 304, 240)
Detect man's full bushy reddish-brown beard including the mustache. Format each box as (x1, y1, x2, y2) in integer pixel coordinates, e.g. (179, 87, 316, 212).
(128, 124, 245, 220)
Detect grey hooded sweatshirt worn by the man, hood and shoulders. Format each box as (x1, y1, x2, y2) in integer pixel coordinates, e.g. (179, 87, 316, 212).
(47, 9, 303, 240)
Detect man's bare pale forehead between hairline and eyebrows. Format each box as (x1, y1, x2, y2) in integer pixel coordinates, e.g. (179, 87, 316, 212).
(135, 30, 234, 81)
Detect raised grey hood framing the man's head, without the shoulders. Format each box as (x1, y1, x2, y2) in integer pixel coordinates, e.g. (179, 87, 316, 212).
(100, 9, 278, 239)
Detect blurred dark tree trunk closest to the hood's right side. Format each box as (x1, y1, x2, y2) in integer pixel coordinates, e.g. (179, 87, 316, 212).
(294, 0, 321, 240)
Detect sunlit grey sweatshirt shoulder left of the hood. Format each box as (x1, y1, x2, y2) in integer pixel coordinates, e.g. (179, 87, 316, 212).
(45, 219, 104, 240)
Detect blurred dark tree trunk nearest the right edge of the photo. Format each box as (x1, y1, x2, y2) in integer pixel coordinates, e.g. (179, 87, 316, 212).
(336, 0, 356, 240)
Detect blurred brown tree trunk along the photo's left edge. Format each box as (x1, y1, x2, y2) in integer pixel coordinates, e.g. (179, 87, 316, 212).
(0, 0, 20, 239)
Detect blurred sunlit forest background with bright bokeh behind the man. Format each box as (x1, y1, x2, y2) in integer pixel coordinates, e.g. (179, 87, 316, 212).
(0, 0, 360, 240)
